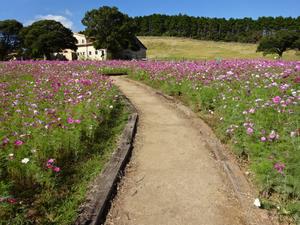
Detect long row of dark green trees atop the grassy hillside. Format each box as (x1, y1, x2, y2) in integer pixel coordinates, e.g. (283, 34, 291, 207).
(133, 14, 300, 43)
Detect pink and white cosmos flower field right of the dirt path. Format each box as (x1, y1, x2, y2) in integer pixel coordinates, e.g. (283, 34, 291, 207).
(126, 60, 300, 222)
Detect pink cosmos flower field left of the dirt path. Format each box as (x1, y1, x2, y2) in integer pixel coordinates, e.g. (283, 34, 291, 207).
(0, 62, 126, 224)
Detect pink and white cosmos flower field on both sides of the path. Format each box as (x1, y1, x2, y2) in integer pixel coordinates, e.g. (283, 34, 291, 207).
(0, 60, 300, 224)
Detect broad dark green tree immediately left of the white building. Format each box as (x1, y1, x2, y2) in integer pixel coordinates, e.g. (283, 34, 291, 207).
(21, 20, 77, 59)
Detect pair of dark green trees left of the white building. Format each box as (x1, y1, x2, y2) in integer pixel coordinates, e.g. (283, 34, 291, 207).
(0, 20, 77, 61)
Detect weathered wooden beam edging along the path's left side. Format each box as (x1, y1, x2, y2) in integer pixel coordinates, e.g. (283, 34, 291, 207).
(74, 96, 138, 225)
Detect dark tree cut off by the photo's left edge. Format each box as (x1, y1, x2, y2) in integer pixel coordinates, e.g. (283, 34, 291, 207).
(0, 20, 23, 60)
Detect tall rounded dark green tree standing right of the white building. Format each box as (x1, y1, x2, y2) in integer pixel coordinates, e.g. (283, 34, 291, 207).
(82, 6, 139, 58)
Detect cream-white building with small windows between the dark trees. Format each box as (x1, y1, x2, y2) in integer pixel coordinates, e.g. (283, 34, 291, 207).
(63, 33, 107, 60)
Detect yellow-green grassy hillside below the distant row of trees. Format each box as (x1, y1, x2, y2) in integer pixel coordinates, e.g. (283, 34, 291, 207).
(139, 36, 300, 60)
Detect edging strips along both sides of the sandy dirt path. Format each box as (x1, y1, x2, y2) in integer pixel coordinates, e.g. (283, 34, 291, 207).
(75, 76, 278, 225)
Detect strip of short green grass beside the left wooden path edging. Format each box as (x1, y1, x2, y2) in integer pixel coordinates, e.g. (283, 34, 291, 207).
(48, 101, 128, 225)
